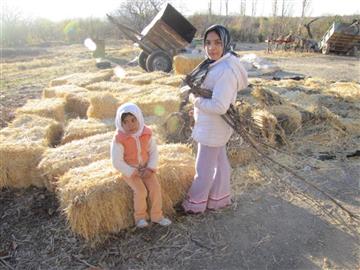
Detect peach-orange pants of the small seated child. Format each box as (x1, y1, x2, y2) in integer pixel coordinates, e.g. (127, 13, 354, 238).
(125, 173, 163, 222)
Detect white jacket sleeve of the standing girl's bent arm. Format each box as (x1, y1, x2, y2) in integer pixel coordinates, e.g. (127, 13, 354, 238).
(194, 68, 237, 115)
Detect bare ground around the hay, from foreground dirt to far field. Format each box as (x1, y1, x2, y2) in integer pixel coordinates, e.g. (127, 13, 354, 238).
(0, 45, 360, 270)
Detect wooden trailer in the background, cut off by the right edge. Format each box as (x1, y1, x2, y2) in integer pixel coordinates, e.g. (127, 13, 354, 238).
(319, 20, 360, 55)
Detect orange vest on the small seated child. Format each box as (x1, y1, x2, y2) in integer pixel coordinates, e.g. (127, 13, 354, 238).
(115, 126, 152, 166)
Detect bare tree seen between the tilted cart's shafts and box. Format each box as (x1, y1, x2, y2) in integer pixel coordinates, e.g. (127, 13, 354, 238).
(115, 0, 165, 31)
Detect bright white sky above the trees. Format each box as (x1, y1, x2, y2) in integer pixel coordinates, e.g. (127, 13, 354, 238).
(1, 0, 360, 21)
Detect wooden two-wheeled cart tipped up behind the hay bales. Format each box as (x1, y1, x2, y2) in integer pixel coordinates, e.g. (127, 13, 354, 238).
(107, 4, 196, 72)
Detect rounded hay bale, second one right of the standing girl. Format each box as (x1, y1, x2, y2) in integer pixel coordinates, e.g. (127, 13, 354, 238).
(268, 105, 302, 135)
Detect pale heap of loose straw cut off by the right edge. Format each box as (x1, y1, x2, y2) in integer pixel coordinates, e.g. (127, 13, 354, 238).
(323, 82, 360, 103)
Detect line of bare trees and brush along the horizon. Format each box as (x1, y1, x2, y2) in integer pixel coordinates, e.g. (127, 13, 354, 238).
(0, 0, 359, 47)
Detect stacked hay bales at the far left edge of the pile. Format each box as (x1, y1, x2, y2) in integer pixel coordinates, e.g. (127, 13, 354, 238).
(0, 115, 63, 188)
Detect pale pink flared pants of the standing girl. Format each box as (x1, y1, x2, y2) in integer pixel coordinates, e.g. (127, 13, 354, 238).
(182, 143, 231, 213)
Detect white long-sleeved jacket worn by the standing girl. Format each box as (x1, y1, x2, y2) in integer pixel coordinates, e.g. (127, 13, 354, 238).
(192, 53, 248, 147)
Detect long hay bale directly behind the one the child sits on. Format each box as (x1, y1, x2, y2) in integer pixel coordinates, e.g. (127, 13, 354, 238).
(38, 132, 114, 190)
